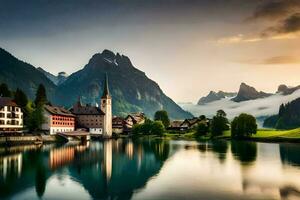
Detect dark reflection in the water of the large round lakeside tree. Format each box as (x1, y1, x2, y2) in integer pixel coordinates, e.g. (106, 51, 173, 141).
(231, 141, 257, 163)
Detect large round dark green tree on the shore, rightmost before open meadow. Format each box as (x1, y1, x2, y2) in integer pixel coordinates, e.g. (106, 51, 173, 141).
(231, 113, 257, 138)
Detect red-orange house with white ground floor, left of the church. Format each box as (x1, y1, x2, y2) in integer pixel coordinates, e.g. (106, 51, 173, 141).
(42, 105, 75, 135)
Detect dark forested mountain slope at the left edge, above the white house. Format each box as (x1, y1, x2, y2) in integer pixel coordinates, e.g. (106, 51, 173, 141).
(0, 48, 56, 100)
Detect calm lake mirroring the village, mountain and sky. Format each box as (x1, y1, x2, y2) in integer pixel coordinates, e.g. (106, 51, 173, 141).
(0, 139, 300, 200)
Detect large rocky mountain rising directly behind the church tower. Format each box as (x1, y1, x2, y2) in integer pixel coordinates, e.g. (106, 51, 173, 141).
(55, 50, 192, 119)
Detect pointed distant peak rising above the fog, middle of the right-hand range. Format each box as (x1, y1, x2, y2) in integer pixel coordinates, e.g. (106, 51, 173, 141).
(232, 83, 272, 102)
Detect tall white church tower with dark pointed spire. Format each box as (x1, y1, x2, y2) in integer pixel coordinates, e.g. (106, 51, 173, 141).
(101, 74, 112, 137)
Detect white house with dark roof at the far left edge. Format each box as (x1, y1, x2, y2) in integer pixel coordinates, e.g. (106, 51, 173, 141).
(0, 97, 23, 133)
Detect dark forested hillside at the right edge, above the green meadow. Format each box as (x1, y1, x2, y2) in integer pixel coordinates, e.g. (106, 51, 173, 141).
(264, 98, 300, 129)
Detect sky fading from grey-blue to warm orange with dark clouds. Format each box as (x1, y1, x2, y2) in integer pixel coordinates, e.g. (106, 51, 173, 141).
(0, 0, 300, 102)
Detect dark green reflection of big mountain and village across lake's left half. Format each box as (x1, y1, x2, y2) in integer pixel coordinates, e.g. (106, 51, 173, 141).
(0, 140, 169, 199)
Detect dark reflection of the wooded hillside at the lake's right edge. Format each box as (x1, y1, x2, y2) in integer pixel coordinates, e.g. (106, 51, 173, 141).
(279, 144, 300, 165)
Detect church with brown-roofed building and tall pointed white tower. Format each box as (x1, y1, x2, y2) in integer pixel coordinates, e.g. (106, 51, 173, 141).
(70, 75, 112, 137)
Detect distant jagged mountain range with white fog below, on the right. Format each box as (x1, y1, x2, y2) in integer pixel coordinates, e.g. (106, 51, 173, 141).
(183, 83, 300, 126)
